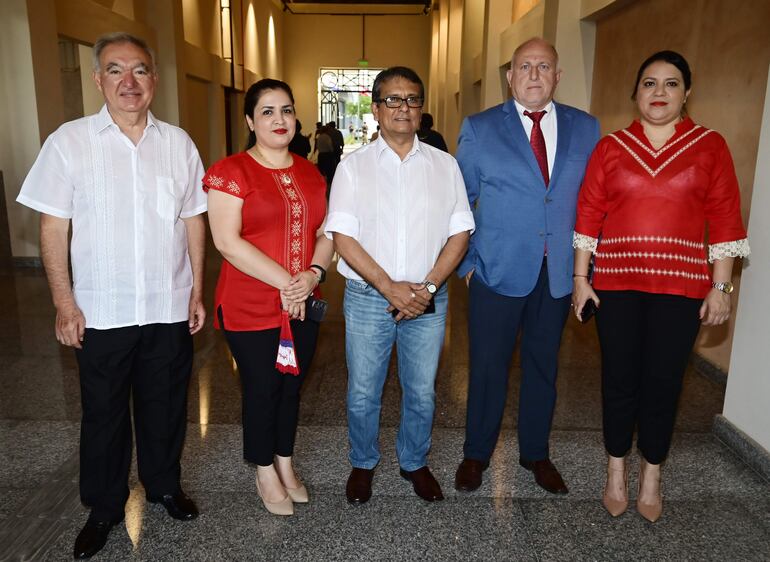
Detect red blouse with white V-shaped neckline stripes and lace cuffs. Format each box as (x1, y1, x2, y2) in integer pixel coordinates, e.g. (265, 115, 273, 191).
(574, 118, 749, 299)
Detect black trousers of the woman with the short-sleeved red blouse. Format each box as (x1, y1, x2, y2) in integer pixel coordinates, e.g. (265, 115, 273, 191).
(220, 309, 318, 466)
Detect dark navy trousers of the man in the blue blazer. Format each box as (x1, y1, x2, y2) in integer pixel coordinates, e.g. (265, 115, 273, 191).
(463, 261, 570, 461)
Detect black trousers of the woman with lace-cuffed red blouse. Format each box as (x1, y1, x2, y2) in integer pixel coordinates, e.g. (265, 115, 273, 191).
(596, 291, 703, 464)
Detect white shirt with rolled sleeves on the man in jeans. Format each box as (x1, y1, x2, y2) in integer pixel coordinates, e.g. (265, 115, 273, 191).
(324, 135, 474, 283)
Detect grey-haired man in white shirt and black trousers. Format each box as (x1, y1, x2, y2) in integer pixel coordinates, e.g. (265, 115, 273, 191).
(17, 34, 206, 558)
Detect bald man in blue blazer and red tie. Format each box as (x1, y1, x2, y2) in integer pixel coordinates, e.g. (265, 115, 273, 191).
(455, 38, 599, 494)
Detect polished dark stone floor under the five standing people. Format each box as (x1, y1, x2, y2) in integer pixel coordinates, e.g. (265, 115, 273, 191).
(0, 253, 770, 561)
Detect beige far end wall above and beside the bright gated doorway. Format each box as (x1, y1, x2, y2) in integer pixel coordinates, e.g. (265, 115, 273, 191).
(283, 14, 431, 136)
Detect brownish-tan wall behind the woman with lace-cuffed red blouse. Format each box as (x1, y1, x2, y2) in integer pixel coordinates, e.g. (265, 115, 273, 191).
(591, 0, 770, 370)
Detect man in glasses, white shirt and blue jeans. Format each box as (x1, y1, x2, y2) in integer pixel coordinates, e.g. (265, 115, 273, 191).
(325, 67, 474, 503)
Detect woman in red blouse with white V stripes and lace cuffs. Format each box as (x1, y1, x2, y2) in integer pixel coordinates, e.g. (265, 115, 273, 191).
(572, 51, 749, 521)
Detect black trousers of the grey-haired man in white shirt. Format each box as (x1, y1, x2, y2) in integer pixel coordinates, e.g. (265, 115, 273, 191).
(76, 321, 193, 520)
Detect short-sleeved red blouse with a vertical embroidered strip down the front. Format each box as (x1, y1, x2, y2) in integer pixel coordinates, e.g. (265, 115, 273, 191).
(203, 152, 326, 331)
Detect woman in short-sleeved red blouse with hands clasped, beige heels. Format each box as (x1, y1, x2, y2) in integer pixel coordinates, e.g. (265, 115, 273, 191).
(203, 79, 333, 515)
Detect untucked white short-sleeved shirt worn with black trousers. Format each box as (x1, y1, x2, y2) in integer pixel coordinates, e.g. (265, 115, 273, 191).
(16, 106, 206, 329)
